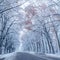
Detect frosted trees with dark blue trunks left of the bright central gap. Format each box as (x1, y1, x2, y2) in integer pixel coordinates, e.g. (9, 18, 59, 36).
(0, 0, 20, 54)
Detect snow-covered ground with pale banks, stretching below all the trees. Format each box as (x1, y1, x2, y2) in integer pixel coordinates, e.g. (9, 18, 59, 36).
(0, 52, 60, 60)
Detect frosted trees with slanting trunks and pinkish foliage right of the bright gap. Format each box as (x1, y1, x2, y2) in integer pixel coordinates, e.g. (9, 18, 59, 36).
(19, 0, 60, 53)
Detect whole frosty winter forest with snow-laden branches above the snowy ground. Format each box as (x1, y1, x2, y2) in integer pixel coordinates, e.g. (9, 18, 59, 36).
(0, 0, 60, 54)
